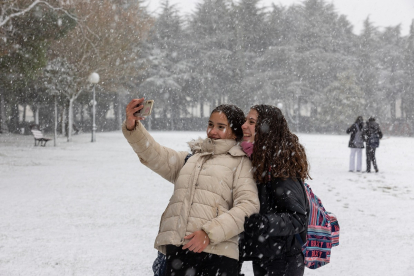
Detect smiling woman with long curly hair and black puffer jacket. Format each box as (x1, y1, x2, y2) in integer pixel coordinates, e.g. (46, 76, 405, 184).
(239, 105, 310, 276)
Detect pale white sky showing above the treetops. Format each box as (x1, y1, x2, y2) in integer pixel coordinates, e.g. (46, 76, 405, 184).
(145, 0, 414, 35)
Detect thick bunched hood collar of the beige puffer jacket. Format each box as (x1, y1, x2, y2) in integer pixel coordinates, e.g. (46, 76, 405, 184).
(187, 138, 246, 156)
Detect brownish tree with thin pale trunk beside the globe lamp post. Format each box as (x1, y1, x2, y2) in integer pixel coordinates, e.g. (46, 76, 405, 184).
(50, 0, 151, 141)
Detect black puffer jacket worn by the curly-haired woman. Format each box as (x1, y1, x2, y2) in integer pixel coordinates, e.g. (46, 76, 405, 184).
(240, 178, 309, 261)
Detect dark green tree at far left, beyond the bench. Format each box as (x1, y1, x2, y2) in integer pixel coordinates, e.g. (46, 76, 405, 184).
(0, 5, 77, 131)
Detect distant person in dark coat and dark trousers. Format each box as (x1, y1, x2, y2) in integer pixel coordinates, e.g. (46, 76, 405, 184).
(363, 117, 382, 173)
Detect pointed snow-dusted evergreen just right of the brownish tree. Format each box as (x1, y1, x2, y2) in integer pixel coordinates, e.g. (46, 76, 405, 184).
(139, 1, 192, 129)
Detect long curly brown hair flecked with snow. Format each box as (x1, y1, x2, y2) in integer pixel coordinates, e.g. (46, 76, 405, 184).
(251, 104, 311, 183)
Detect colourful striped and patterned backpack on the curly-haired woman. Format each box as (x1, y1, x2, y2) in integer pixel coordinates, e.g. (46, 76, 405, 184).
(296, 183, 339, 269)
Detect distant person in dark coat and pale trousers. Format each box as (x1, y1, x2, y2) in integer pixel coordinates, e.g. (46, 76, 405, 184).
(346, 116, 364, 172)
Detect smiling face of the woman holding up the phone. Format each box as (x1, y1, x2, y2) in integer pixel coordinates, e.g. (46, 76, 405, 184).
(207, 112, 236, 140)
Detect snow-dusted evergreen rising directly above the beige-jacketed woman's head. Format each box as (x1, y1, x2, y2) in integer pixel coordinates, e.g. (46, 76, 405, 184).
(188, 0, 235, 116)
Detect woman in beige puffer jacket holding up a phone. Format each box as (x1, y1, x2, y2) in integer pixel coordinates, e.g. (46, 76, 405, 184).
(122, 99, 259, 276)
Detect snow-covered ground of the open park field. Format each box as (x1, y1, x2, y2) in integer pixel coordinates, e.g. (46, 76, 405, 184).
(0, 132, 414, 276)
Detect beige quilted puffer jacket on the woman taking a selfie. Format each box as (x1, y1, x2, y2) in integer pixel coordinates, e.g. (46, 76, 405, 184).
(122, 123, 260, 260)
